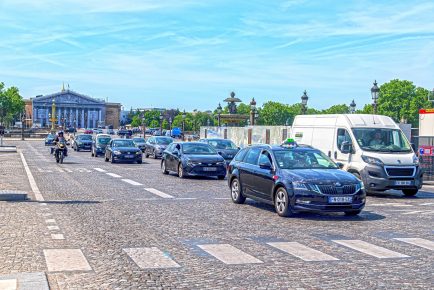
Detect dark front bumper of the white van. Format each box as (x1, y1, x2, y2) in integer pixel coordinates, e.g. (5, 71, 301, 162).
(360, 165, 423, 192)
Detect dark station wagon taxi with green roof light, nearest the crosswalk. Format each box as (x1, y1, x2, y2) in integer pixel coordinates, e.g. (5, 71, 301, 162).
(228, 145, 366, 216)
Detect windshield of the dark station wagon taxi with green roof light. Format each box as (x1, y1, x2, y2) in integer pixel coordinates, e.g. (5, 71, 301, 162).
(274, 150, 338, 169)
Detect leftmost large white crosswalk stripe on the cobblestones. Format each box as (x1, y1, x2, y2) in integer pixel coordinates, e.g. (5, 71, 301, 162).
(44, 249, 92, 272)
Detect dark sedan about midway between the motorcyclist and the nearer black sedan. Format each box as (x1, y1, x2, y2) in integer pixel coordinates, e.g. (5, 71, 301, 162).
(105, 139, 142, 164)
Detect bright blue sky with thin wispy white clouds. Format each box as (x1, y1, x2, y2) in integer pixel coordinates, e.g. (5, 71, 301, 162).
(0, 0, 434, 111)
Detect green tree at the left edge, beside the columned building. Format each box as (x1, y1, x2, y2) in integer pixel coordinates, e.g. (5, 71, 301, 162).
(0, 82, 24, 125)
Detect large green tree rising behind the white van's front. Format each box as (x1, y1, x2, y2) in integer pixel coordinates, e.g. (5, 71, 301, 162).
(377, 79, 431, 127)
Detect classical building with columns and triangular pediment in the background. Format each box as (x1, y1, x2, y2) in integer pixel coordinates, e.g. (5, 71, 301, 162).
(26, 89, 121, 128)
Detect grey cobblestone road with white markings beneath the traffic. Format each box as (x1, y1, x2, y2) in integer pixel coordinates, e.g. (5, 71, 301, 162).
(0, 141, 434, 289)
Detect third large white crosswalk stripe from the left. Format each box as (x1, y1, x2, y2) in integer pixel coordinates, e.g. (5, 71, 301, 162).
(198, 244, 262, 265)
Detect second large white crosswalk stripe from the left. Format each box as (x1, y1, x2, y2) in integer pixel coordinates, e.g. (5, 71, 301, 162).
(123, 247, 180, 269)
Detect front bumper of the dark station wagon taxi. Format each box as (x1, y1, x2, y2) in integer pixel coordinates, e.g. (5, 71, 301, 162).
(291, 190, 366, 212)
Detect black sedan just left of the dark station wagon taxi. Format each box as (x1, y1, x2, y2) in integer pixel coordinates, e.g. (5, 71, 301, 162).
(161, 142, 226, 179)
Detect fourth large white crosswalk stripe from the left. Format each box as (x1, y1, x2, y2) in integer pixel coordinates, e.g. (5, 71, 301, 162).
(267, 242, 339, 262)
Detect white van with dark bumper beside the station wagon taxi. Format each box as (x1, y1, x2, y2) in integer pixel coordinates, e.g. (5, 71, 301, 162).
(291, 114, 423, 196)
